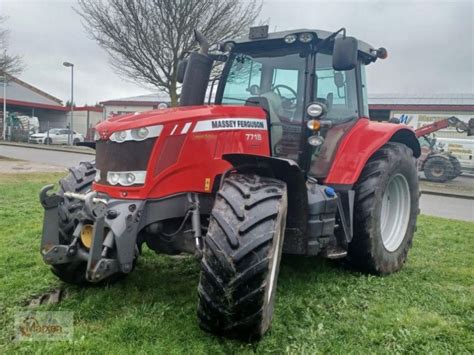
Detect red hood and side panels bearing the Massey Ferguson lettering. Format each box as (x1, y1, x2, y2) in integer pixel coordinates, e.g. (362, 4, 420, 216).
(94, 106, 270, 199)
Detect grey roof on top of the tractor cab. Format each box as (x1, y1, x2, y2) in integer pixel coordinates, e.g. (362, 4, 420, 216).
(224, 26, 377, 63)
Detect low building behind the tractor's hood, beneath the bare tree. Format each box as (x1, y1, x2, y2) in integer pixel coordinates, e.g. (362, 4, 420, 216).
(100, 93, 170, 118)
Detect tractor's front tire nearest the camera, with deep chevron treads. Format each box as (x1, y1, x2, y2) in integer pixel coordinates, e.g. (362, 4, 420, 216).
(198, 174, 287, 340)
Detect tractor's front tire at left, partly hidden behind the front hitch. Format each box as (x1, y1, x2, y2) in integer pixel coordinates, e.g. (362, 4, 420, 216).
(51, 162, 96, 285)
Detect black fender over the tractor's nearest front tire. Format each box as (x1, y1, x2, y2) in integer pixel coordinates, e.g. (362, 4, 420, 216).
(222, 154, 308, 237)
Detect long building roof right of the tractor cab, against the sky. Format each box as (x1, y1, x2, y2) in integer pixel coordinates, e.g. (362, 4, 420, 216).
(369, 93, 474, 111)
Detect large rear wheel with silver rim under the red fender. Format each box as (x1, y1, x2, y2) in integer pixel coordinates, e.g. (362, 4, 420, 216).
(348, 143, 419, 274)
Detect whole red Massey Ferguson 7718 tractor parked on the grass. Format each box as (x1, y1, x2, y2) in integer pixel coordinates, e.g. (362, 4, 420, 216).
(40, 26, 420, 339)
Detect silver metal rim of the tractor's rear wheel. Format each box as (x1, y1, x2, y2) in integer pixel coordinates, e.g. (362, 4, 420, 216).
(380, 174, 411, 252)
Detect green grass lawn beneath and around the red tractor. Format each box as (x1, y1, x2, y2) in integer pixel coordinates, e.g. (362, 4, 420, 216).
(0, 174, 474, 354)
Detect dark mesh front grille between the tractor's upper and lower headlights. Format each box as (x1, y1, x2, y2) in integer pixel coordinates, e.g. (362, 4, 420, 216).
(95, 138, 156, 185)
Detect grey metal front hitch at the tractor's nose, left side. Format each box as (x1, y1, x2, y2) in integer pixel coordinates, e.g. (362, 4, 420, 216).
(40, 185, 145, 283)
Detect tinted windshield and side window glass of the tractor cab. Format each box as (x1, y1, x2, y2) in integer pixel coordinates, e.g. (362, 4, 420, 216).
(222, 52, 359, 122)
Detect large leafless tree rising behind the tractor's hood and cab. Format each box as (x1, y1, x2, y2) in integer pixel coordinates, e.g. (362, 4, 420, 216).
(77, 0, 262, 106)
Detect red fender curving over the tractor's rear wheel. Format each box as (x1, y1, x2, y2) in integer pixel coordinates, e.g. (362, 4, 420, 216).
(324, 117, 421, 186)
